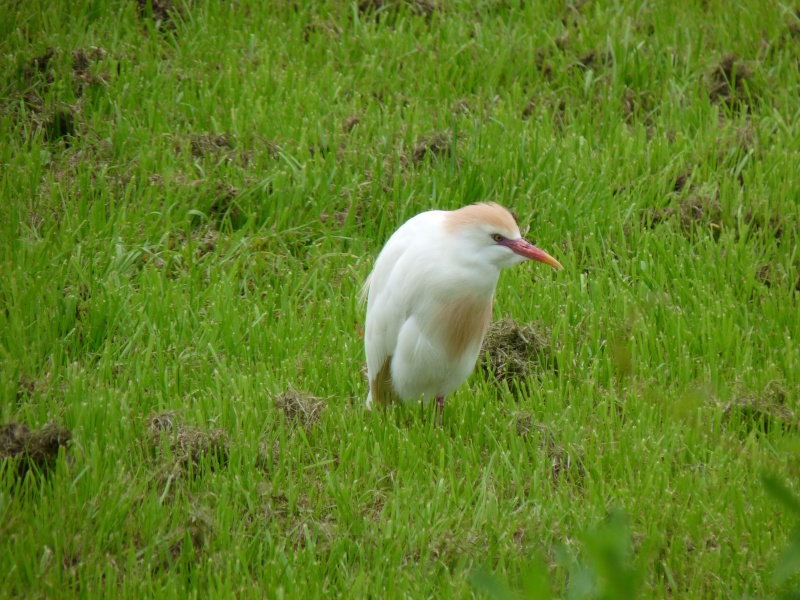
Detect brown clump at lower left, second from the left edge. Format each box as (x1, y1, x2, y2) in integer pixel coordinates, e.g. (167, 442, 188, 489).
(147, 411, 230, 471)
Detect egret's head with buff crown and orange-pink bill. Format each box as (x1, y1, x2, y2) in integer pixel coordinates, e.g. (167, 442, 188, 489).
(445, 202, 564, 269)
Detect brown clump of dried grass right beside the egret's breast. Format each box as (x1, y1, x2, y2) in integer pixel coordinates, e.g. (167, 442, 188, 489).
(481, 317, 551, 381)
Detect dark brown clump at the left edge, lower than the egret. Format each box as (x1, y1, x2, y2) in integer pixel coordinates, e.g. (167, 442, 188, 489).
(0, 423, 72, 475)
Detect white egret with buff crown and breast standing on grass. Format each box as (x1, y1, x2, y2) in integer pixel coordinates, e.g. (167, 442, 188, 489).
(363, 203, 563, 410)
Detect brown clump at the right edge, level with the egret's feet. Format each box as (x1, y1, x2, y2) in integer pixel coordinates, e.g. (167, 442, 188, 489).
(723, 381, 800, 433)
